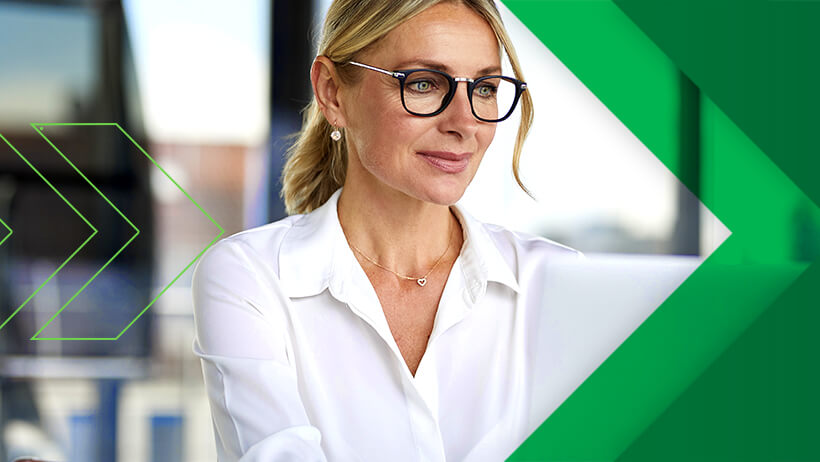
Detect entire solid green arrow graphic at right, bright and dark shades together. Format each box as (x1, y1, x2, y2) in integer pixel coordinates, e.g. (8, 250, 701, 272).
(504, 0, 820, 461)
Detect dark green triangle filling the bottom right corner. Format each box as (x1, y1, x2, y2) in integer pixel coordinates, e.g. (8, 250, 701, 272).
(618, 263, 820, 462)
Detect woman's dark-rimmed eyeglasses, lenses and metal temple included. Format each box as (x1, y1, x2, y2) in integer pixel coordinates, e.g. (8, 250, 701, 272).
(347, 61, 527, 122)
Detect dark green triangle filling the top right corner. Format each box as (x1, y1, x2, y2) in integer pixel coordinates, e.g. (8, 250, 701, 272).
(616, 0, 820, 205)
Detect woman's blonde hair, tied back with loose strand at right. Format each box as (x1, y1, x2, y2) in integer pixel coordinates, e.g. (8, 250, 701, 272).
(282, 0, 533, 214)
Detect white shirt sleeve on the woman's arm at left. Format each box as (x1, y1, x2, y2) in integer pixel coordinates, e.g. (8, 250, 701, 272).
(192, 240, 327, 462)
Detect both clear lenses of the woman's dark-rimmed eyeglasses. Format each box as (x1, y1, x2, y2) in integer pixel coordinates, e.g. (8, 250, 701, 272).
(404, 71, 516, 120)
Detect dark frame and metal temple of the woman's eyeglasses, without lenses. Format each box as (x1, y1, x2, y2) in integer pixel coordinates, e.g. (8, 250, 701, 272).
(346, 61, 527, 123)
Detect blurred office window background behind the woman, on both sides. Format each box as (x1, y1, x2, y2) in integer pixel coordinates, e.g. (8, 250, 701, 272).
(0, 0, 818, 462)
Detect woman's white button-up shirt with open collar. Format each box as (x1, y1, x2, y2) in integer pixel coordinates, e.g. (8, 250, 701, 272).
(193, 190, 576, 462)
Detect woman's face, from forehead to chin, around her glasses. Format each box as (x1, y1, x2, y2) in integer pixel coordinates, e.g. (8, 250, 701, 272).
(341, 3, 501, 205)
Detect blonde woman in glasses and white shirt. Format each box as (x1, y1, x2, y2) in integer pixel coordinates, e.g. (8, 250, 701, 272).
(193, 0, 574, 461)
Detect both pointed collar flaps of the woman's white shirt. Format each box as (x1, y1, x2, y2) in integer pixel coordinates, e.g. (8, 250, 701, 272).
(279, 188, 520, 303)
